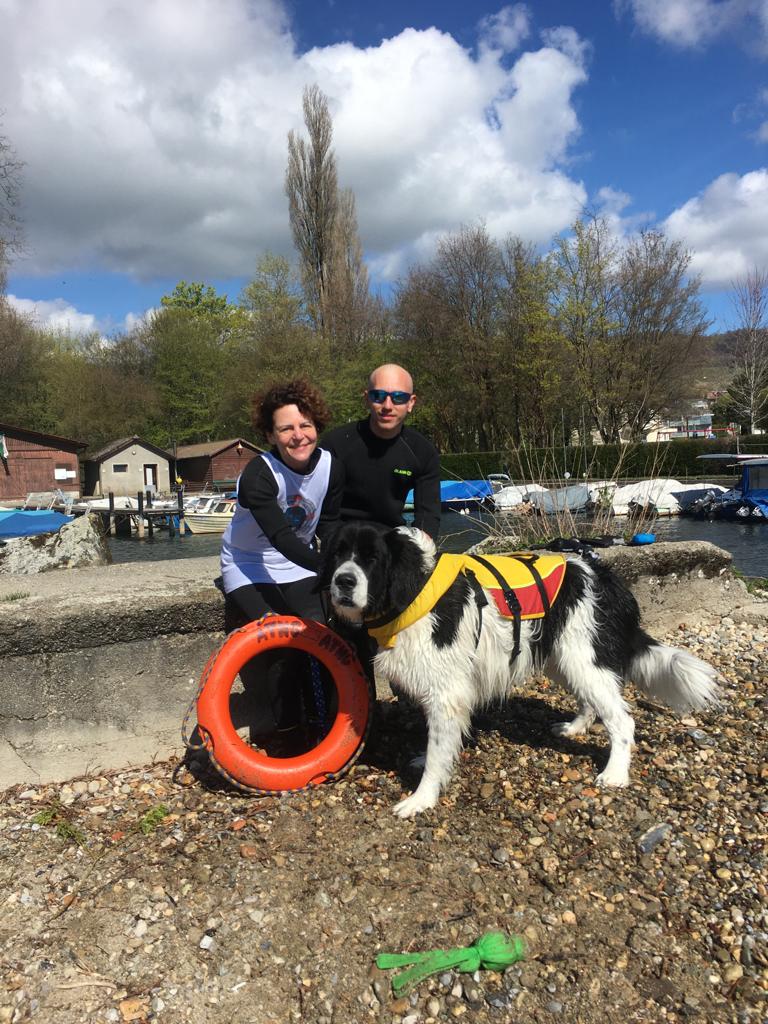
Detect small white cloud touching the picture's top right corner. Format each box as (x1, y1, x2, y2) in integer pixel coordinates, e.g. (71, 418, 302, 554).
(614, 0, 768, 49)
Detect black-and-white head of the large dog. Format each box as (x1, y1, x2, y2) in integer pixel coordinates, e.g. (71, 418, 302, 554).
(321, 522, 435, 623)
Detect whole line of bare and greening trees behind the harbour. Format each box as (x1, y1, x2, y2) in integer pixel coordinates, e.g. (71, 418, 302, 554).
(0, 87, 768, 452)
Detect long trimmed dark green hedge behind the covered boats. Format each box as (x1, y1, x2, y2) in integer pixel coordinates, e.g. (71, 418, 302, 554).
(440, 436, 768, 480)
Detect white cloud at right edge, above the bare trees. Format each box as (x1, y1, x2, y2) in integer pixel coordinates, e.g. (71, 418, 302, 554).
(664, 168, 768, 288)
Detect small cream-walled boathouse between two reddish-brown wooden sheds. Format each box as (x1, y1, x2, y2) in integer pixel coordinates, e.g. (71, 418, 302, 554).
(85, 436, 173, 498)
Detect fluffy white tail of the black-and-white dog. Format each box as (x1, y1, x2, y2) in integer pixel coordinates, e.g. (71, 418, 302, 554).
(630, 637, 720, 712)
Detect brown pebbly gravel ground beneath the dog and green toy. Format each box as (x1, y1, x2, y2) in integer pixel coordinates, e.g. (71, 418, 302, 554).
(0, 618, 768, 1024)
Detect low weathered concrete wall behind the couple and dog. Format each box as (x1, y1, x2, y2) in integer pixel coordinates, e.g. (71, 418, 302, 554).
(0, 541, 768, 788)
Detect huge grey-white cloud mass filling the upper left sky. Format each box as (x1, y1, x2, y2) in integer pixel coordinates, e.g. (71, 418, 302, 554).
(0, 0, 587, 280)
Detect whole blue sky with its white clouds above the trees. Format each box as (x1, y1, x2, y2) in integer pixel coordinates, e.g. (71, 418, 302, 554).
(0, 0, 768, 336)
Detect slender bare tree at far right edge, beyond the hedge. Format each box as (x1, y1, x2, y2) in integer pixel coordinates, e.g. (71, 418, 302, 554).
(728, 267, 768, 434)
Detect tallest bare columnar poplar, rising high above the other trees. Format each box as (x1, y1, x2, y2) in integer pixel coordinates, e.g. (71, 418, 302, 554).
(286, 85, 339, 330)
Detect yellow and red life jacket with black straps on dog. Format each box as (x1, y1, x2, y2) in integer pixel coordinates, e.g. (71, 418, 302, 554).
(366, 552, 565, 647)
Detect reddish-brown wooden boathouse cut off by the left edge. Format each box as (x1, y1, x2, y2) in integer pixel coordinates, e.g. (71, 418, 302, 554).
(0, 423, 87, 502)
